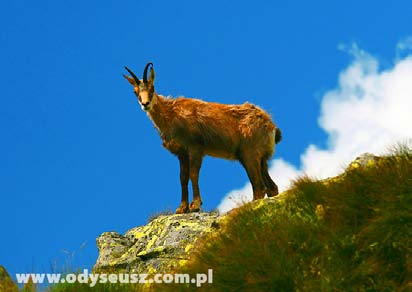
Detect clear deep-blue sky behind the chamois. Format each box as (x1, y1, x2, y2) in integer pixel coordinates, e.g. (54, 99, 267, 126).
(0, 1, 412, 273)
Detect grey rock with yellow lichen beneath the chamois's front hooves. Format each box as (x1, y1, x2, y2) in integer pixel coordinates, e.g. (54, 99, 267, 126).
(93, 213, 220, 274)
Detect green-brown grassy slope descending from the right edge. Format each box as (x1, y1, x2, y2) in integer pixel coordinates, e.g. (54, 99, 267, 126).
(46, 149, 412, 291)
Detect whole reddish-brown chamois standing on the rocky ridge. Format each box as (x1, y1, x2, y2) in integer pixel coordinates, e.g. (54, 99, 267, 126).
(123, 63, 282, 214)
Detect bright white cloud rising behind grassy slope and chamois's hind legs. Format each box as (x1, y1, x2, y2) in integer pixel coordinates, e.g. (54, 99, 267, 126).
(218, 41, 412, 212)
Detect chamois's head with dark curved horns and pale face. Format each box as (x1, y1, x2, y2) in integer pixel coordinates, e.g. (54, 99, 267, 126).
(123, 63, 156, 111)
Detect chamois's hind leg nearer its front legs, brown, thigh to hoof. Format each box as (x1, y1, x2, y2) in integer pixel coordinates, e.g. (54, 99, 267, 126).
(240, 156, 265, 200)
